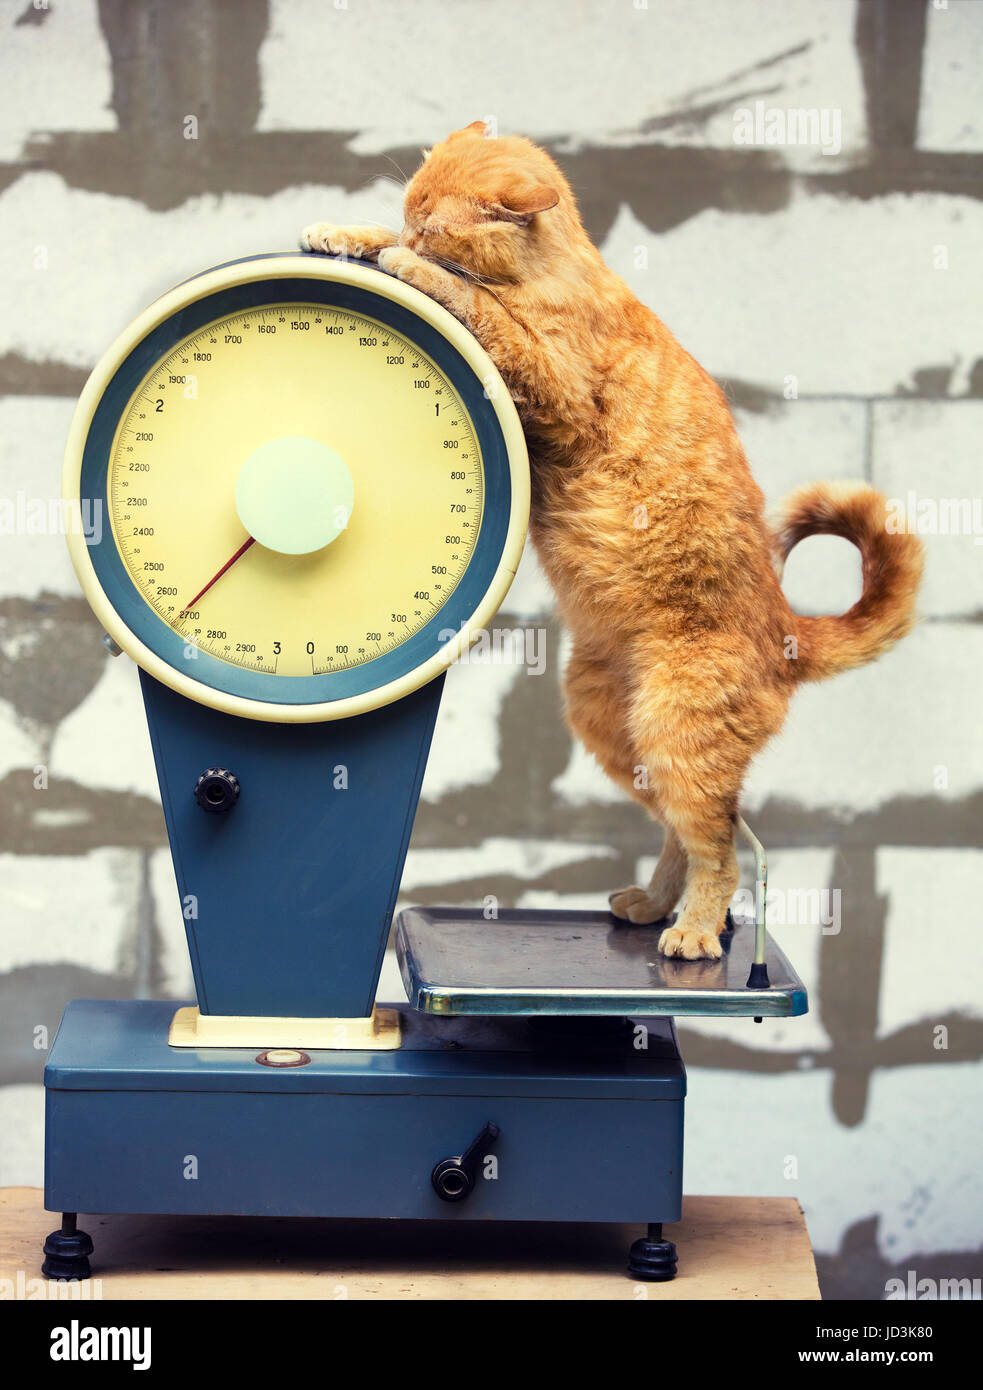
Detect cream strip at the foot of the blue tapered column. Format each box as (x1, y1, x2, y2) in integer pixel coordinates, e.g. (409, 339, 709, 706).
(167, 1004, 402, 1052)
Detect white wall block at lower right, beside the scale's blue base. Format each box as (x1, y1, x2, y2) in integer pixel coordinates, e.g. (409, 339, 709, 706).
(685, 1056, 983, 1267)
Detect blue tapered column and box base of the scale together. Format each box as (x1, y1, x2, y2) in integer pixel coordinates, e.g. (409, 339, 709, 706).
(44, 673, 685, 1222)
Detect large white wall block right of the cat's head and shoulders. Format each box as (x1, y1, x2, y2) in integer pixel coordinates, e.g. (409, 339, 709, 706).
(603, 190, 983, 396)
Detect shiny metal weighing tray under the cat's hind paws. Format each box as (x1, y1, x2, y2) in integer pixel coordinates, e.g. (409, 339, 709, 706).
(395, 908, 808, 1017)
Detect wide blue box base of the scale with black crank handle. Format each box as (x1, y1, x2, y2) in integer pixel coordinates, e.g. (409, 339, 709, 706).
(44, 999, 685, 1277)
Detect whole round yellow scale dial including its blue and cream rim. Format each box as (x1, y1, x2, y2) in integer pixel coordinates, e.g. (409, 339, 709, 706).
(65, 254, 528, 721)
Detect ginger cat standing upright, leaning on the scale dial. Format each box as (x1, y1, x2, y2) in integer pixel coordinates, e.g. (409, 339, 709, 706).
(302, 121, 922, 959)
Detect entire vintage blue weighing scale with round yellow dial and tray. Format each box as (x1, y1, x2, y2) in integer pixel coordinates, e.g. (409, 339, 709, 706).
(44, 253, 806, 1279)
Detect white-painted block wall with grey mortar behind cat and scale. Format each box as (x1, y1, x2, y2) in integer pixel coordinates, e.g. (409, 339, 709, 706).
(0, 0, 983, 1297)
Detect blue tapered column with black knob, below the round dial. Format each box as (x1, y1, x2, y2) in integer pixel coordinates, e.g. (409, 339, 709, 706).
(140, 671, 444, 1017)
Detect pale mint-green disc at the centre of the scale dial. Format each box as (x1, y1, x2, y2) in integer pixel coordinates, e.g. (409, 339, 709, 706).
(235, 435, 355, 555)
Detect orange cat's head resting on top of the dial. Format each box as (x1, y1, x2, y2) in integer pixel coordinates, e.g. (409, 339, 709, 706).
(399, 121, 578, 281)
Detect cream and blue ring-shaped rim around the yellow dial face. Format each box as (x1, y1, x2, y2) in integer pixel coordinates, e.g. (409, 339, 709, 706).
(63, 252, 530, 723)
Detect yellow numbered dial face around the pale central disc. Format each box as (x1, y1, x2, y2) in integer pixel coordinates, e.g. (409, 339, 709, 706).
(108, 303, 482, 676)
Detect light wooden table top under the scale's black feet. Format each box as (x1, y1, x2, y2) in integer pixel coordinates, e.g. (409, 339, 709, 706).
(0, 1187, 820, 1301)
